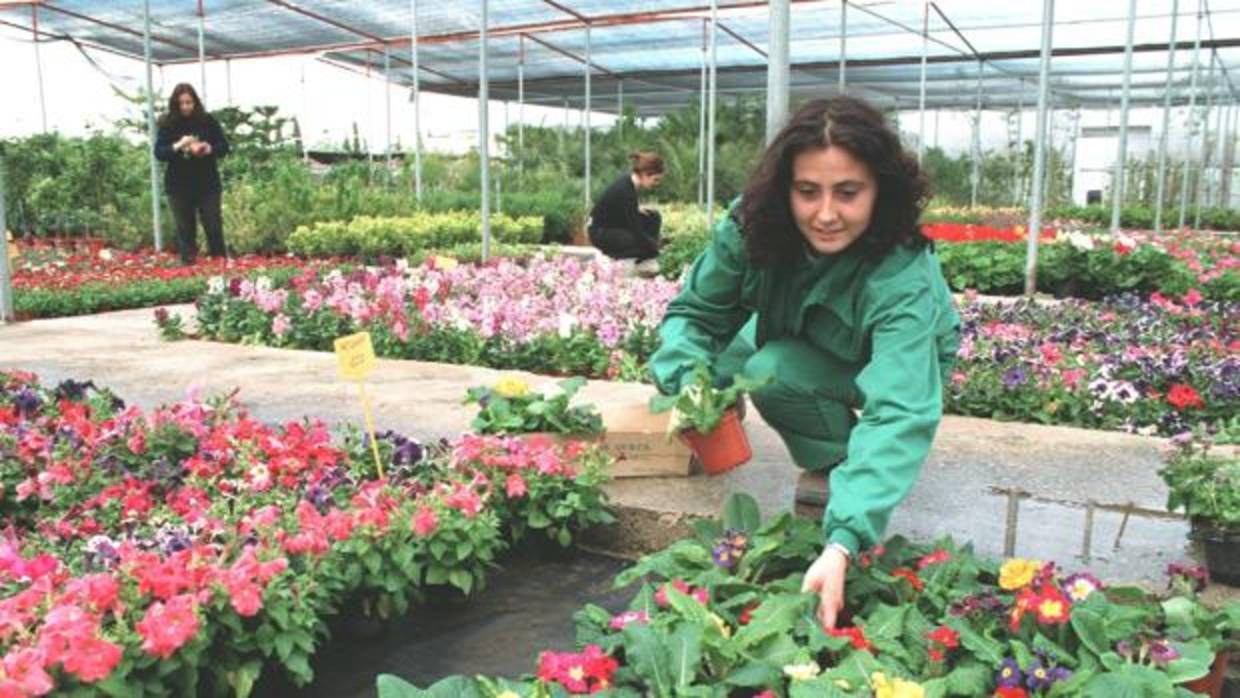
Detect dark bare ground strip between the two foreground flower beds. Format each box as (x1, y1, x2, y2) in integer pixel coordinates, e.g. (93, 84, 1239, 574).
(254, 552, 635, 698)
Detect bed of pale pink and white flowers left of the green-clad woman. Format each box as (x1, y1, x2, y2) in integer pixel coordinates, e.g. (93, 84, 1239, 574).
(189, 257, 677, 377)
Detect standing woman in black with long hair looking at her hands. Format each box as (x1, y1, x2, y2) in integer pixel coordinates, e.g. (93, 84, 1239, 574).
(155, 82, 228, 264)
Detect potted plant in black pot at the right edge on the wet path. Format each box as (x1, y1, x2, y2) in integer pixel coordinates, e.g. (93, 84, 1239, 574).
(1158, 420, 1240, 586)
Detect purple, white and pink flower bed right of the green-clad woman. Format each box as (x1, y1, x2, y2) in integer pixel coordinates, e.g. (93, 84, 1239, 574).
(945, 295, 1240, 435)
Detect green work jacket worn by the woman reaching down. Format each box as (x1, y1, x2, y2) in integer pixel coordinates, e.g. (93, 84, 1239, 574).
(651, 210, 960, 553)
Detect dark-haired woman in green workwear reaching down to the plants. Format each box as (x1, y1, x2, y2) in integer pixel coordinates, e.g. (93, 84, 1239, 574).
(651, 97, 960, 627)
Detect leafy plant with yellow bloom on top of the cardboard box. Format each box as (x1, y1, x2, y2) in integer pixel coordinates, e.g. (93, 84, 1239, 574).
(465, 376, 603, 434)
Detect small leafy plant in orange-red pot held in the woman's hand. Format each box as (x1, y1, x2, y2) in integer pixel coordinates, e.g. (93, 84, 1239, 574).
(650, 362, 770, 475)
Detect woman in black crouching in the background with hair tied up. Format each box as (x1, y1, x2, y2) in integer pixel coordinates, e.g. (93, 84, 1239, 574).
(589, 152, 663, 270)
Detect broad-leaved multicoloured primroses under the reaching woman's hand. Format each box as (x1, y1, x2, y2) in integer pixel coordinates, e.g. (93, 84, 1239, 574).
(379, 500, 1240, 698)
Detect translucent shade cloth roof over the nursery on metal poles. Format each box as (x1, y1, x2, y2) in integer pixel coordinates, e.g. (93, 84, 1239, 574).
(0, 0, 1240, 115)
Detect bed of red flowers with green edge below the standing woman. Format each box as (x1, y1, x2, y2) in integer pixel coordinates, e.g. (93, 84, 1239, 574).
(12, 241, 304, 317)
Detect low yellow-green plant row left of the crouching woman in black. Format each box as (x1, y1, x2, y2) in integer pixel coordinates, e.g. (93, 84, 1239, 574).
(286, 211, 543, 259)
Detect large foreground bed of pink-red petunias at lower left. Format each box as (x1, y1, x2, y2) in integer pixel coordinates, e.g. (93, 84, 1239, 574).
(0, 372, 610, 697)
